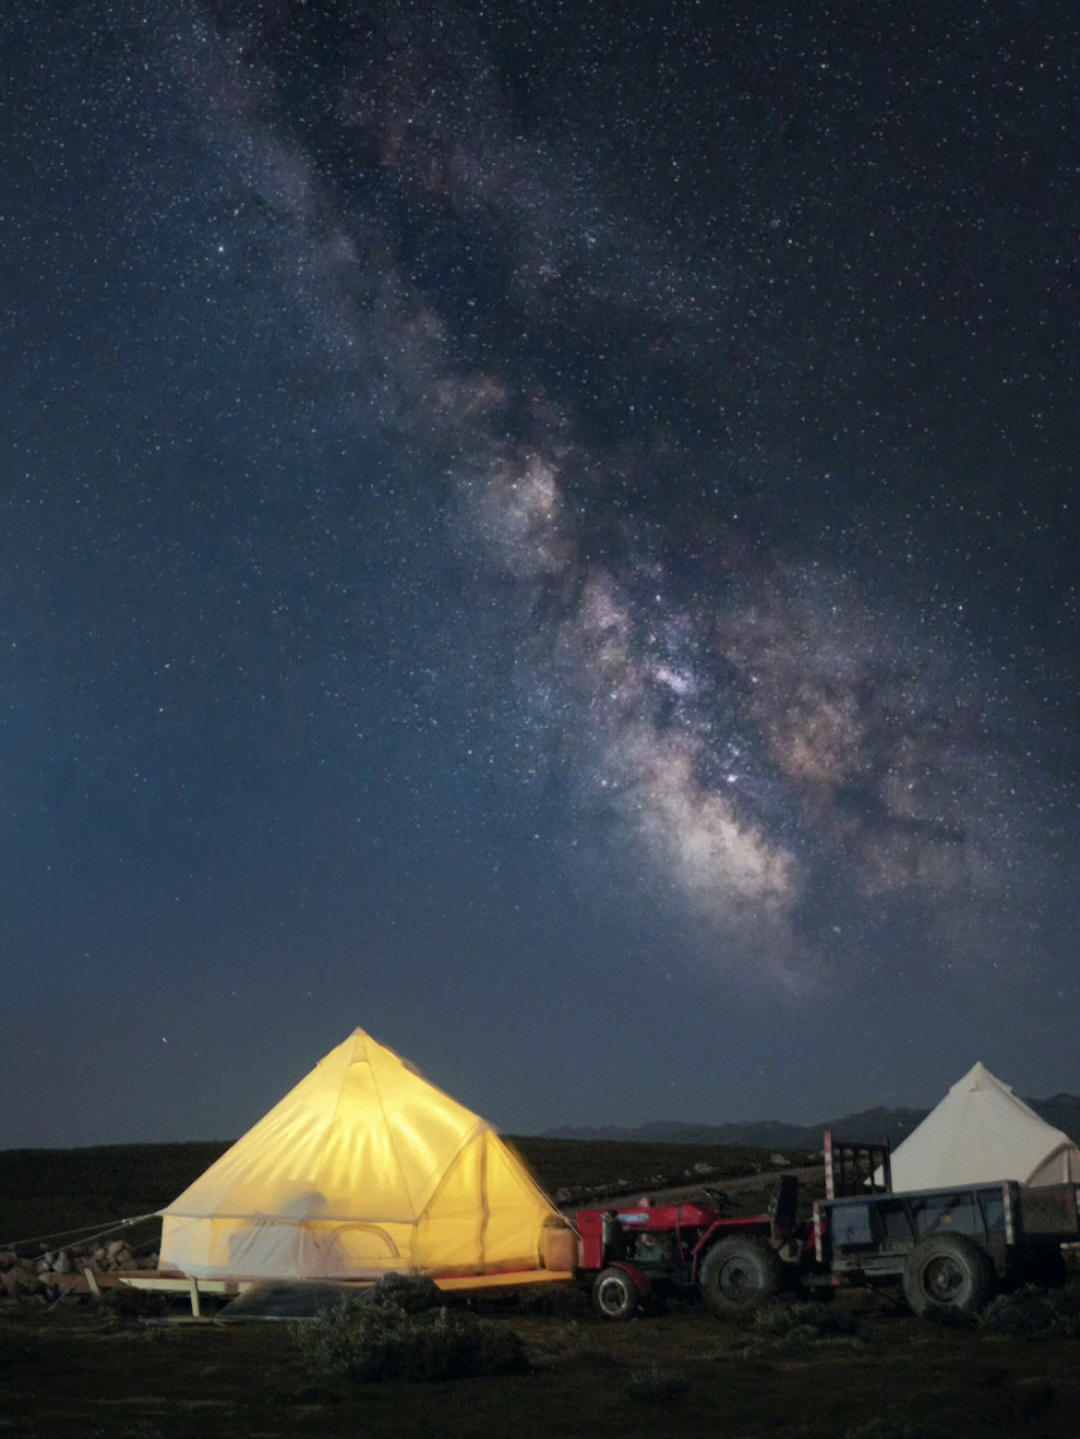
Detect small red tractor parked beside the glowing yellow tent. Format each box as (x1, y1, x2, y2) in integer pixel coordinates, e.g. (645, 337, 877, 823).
(575, 1174, 804, 1320)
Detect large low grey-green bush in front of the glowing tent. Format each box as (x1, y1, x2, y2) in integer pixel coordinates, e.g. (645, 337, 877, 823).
(295, 1291, 526, 1381)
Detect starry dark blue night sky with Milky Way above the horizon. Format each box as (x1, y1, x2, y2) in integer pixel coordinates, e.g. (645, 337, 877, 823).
(0, 0, 1080, 1147)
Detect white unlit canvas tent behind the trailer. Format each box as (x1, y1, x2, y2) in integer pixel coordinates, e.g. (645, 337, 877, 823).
(892, 1063, 1080, 1193)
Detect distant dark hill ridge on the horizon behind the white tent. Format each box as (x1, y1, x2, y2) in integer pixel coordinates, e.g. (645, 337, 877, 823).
(545, 1094, 1080, 1150)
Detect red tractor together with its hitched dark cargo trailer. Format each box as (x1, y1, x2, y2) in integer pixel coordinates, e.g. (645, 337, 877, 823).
(575, 1134, 1080, 1320)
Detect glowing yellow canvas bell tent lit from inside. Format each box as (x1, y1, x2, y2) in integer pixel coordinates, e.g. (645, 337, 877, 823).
(160, 1029, 561, 1279)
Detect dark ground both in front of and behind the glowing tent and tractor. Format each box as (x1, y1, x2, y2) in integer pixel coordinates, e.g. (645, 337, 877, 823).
(0, 1141, 1080, 1439)
